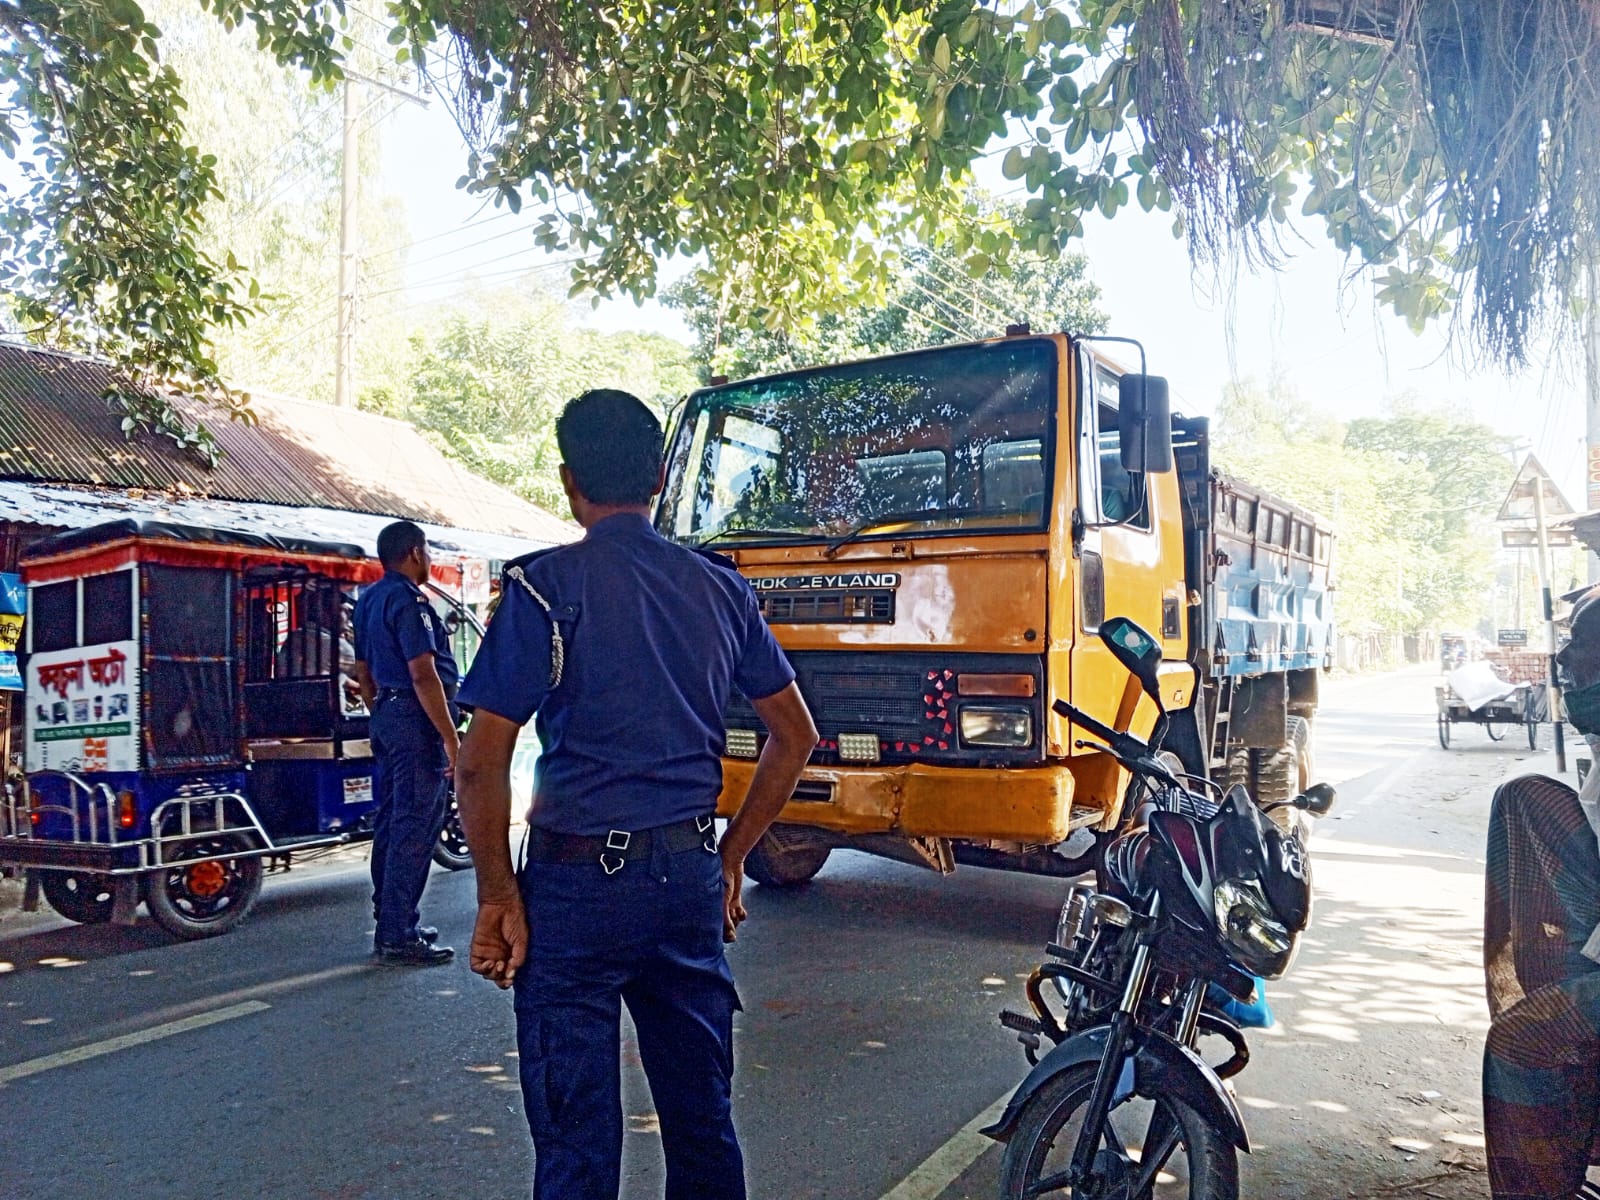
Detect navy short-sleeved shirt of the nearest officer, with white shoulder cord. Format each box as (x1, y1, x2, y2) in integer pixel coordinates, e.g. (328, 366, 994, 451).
(459, 514, 795, 835)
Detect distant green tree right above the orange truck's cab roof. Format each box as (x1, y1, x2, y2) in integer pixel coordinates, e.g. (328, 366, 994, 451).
(662, 232, 1106, 381)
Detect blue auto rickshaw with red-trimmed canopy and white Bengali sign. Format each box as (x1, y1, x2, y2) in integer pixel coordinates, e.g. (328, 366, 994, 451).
(0, 520, 482, 938)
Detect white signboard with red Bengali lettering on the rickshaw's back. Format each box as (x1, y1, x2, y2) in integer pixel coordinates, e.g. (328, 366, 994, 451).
(27, 642, 139, 771)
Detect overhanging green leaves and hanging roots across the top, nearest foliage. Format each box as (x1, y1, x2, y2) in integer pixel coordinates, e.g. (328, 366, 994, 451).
(0, 0, 1600, 454)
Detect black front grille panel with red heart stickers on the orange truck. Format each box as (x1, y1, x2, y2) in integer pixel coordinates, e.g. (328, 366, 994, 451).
(725, 651, 1045, 765)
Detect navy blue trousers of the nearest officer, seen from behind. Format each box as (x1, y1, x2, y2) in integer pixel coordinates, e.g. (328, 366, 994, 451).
(515, 832, 744, 1200)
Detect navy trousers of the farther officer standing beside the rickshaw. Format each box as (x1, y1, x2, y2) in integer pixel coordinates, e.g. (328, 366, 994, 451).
(370, 696, 450, 946)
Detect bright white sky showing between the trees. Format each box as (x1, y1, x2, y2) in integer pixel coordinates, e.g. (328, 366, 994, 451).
(379, 82, 1600, 510)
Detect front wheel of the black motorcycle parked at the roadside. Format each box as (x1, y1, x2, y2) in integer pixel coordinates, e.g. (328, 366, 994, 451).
(1000, 1062, 1238, 1200)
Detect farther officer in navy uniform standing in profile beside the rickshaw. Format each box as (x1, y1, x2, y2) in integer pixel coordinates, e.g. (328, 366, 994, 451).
(354, 522, 461, 966)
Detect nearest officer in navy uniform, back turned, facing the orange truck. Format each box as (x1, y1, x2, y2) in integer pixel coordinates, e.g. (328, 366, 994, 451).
(458, 390, 816, 1200)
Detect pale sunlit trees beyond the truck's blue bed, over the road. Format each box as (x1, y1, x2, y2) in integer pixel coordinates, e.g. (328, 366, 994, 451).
(1213, 384, 1514, 634)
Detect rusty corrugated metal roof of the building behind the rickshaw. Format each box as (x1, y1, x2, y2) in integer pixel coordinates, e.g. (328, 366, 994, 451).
(0, 342, 578, 544)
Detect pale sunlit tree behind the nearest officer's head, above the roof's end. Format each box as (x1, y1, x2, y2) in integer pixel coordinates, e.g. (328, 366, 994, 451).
(362, 288, 694, 514)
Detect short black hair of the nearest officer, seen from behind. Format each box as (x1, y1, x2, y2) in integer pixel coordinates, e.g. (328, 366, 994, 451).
(555, 387, 662, 506)
